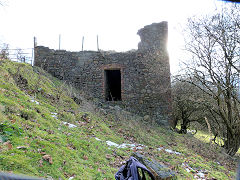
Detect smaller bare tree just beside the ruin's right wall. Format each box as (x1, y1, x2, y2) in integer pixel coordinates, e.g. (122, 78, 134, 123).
(172, 77, 207, 134)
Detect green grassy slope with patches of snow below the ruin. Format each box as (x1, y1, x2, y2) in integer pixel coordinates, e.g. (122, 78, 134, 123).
(0, 61, 235, 179)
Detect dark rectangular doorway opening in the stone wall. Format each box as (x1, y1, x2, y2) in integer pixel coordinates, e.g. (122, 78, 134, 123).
(104, 69, 122, 101)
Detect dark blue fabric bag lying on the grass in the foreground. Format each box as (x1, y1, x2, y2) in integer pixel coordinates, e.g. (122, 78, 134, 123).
(115, 156, 155, 180)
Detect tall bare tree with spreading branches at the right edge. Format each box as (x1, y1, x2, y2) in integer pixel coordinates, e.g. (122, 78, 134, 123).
(182, 5, 240, 156)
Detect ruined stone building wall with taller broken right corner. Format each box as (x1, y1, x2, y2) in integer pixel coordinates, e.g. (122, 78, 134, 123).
(34, 22, 172, 126)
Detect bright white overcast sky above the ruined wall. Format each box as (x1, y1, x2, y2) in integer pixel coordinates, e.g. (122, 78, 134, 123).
(0, 0, 229, 73)
